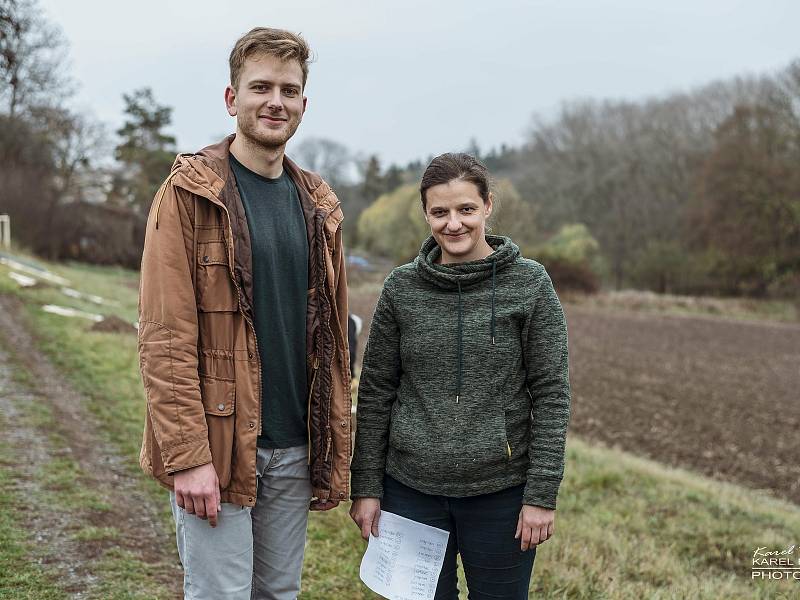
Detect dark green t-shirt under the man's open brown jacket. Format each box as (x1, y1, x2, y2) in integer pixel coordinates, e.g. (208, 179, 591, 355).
(230, 154, 308, 448)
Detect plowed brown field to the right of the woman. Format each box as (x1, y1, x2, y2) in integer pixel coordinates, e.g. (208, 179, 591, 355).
(567, 306, 800, 503)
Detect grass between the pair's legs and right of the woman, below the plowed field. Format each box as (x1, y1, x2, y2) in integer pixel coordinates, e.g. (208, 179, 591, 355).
(301, 438, 800, 600)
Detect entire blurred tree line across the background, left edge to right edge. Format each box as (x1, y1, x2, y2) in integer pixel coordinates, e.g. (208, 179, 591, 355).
(0, 0, 800, 297)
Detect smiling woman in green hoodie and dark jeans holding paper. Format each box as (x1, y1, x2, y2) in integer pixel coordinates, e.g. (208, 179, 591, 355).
(350, 154, 570, 599)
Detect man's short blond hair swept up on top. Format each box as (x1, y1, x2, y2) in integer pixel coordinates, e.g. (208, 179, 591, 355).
(229, 27, 311, 89)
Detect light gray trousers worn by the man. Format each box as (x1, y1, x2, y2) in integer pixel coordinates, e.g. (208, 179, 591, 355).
(170, 446, 311, 600)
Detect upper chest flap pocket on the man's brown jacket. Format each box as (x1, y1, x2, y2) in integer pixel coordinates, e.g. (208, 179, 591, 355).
(197, 241, 239, 312)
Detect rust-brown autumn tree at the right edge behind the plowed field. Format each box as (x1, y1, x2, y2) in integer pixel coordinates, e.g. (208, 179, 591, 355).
(693, 105, 800, 295)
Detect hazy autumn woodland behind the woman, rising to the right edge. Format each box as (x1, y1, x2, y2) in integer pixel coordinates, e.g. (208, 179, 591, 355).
(343, 60, 800, 297)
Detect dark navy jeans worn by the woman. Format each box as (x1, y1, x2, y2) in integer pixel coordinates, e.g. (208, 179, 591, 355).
(381, 475, 536, 600)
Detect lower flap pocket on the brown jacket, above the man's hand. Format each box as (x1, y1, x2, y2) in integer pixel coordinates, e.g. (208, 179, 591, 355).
(200, 374, 236, 490)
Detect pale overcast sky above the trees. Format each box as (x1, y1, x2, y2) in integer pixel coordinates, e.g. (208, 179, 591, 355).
(41, 0, 800, 164)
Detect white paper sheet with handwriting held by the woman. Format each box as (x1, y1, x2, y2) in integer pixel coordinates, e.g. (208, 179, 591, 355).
(359, 510, 450, 600)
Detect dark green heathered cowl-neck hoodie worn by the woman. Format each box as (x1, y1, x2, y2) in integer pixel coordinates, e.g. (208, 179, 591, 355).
(351, 236, 570, 508)
